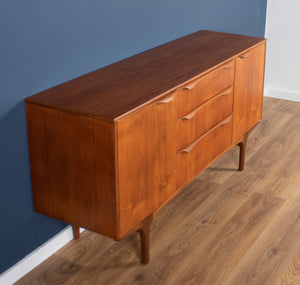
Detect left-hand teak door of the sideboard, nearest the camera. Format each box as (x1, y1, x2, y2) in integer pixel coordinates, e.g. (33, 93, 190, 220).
(118, 95, 176, 236)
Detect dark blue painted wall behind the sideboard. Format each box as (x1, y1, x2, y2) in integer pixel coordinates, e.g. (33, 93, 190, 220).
(0, 0, 267, 273)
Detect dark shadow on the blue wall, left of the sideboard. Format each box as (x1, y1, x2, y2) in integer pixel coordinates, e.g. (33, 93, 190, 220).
(0, 101, 66, 272)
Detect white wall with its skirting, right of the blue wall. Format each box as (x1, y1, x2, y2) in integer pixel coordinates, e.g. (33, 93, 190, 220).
(265, 0, 300, 102)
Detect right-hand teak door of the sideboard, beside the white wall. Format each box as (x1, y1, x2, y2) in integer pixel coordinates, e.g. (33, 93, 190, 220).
(233, 44, 265, 142)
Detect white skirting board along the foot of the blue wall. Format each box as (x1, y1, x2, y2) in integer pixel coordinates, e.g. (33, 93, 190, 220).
(0, 226, 84, 285)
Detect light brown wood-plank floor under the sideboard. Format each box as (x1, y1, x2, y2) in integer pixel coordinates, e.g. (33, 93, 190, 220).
(16, 98, 300, 285)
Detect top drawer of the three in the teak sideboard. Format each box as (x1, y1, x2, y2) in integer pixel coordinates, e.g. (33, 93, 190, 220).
(176, 60, 234, 117)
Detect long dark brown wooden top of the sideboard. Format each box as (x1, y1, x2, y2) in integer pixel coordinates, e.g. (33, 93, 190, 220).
(26, 30, 265, 121)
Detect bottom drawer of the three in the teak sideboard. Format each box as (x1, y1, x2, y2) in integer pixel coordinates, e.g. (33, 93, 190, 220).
(176, 115, 232, 189)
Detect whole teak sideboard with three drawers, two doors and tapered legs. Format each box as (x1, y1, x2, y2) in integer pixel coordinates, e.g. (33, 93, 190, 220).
(26, 31, 266, 263)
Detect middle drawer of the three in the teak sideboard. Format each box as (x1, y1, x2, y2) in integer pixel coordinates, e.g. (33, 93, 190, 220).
(176, 86, 233, 151)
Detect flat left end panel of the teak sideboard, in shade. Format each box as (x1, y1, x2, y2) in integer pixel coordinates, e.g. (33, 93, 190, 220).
(26, 103, 118, 238)
